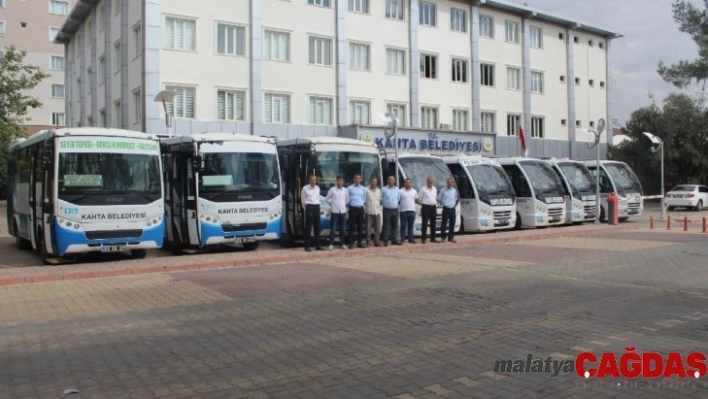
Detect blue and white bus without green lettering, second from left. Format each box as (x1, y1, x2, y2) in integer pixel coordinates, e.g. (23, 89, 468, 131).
(162, 133, 283, 254)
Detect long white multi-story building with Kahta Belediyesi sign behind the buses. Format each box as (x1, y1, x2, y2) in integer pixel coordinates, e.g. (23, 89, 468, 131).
(57, 0, 619, 157)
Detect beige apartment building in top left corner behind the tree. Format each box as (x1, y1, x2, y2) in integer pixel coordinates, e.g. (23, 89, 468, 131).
(0, 0, 75, 131)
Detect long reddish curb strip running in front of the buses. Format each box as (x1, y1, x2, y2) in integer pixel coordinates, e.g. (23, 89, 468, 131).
(0, 225, 642, 286)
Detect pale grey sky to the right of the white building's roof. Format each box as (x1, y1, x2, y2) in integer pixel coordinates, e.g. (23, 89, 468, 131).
(512, 0, 703, 126)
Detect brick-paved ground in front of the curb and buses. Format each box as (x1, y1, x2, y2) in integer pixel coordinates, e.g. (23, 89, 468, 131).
(0, 230, 708, 399)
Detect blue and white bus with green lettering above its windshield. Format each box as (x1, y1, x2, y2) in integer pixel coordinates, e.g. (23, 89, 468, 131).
(7, 127, 164, 264)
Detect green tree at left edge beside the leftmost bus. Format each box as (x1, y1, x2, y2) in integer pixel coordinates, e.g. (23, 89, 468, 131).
(0, 46, 49, 196)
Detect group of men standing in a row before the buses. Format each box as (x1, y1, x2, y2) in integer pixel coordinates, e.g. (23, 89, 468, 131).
(301, 174, 460, 252)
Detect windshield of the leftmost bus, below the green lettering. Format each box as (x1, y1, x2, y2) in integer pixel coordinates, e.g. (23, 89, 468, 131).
(58, 152, 162, 204)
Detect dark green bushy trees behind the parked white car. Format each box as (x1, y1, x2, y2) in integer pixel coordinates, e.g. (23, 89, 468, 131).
(608, 93, 708, 194)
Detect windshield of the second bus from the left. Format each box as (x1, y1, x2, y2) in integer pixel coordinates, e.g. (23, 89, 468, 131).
(199, 151, 280, 194)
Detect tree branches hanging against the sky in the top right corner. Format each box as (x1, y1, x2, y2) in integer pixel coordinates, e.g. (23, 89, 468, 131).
(658, 0, 708, 89)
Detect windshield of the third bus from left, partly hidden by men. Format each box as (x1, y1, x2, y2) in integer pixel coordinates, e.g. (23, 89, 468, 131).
(315, 151, 381, 195)
